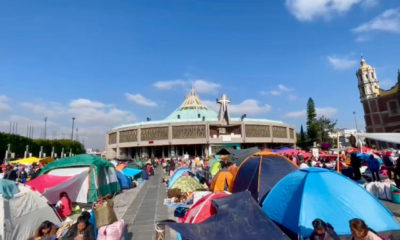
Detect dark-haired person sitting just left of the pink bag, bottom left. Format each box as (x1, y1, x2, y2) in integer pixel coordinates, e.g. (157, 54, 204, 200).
(62, 212, 95, 240)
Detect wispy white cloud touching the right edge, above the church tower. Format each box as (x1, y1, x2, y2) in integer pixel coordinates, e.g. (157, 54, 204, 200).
(353, 9, 400, 33)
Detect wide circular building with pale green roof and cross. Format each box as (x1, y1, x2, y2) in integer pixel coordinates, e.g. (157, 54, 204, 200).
(106, 89, 296, 159)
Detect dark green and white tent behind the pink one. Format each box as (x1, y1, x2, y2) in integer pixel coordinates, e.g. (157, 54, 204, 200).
(40, 154, 121, 203)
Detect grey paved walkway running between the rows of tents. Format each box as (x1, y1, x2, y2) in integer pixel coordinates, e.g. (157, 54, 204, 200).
(123, 167, 176, 240)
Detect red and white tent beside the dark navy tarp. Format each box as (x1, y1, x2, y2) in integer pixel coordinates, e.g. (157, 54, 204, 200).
(183, 192, 229, 224)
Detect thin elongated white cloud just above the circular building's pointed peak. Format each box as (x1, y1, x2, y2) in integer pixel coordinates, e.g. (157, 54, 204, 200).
(153, 79, 221, 93)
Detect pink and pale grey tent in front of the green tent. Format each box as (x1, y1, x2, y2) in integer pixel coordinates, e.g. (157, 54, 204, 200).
(26, 172, 88, 204)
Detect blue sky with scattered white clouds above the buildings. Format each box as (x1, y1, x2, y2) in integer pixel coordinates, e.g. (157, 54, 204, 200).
(0, 0, 400, 148)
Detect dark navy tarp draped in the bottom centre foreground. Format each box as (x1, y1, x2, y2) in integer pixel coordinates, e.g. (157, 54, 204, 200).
(166, 191, 289, 240)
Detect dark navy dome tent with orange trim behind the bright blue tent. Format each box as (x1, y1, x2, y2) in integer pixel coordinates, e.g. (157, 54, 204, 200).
(232, 152, 297, 203)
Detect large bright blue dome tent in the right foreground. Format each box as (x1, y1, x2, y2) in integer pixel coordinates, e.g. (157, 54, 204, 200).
(262, 168, 400, 238)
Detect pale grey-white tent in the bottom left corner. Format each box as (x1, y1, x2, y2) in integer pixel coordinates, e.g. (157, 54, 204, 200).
(0, 179, 61, 240)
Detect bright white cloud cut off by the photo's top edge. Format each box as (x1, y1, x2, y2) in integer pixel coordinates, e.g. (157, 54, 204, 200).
(286, 0, 364, 21)
